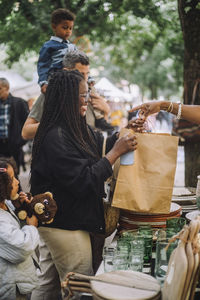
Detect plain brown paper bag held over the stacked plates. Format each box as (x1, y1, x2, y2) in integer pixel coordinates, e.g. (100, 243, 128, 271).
(112, 129, 178, 214)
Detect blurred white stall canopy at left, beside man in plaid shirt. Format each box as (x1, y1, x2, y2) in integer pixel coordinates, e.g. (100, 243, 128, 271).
(0, 70, 40, 100)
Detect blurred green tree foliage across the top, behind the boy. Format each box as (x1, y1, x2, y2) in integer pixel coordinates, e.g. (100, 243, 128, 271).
(0, 0, 183, 95)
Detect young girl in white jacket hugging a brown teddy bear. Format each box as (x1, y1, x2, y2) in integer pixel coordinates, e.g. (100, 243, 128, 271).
(0, 160, 39, 300)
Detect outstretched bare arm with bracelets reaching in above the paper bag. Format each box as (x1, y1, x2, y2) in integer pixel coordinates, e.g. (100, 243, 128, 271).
(130, 101, 200, 124)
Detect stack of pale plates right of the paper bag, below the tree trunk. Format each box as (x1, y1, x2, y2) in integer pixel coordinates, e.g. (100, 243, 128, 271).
(172, 188, 197, 215)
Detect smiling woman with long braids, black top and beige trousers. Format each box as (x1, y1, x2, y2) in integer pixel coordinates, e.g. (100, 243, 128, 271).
(31, 70, 143, 300)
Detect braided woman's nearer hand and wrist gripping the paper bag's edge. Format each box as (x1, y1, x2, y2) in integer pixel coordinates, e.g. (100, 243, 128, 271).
(105, 133, 137, 165)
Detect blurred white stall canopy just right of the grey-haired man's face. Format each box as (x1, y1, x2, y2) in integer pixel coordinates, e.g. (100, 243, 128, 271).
(95, 77, 133, 102)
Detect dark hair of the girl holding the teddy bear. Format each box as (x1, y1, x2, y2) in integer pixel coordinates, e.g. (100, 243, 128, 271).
(0, 160, 12, 202)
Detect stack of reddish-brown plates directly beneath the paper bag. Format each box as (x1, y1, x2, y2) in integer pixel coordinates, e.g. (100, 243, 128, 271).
(119, 203, 182, 230)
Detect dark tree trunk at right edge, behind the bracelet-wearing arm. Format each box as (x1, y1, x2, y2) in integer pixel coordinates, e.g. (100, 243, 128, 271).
(178, 0, 200, 187)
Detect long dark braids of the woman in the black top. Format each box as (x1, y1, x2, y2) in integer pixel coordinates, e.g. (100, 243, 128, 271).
(32, 70, 100, 165)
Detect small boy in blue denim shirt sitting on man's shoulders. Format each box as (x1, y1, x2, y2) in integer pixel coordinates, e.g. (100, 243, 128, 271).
(37, 8, 76, 93)
